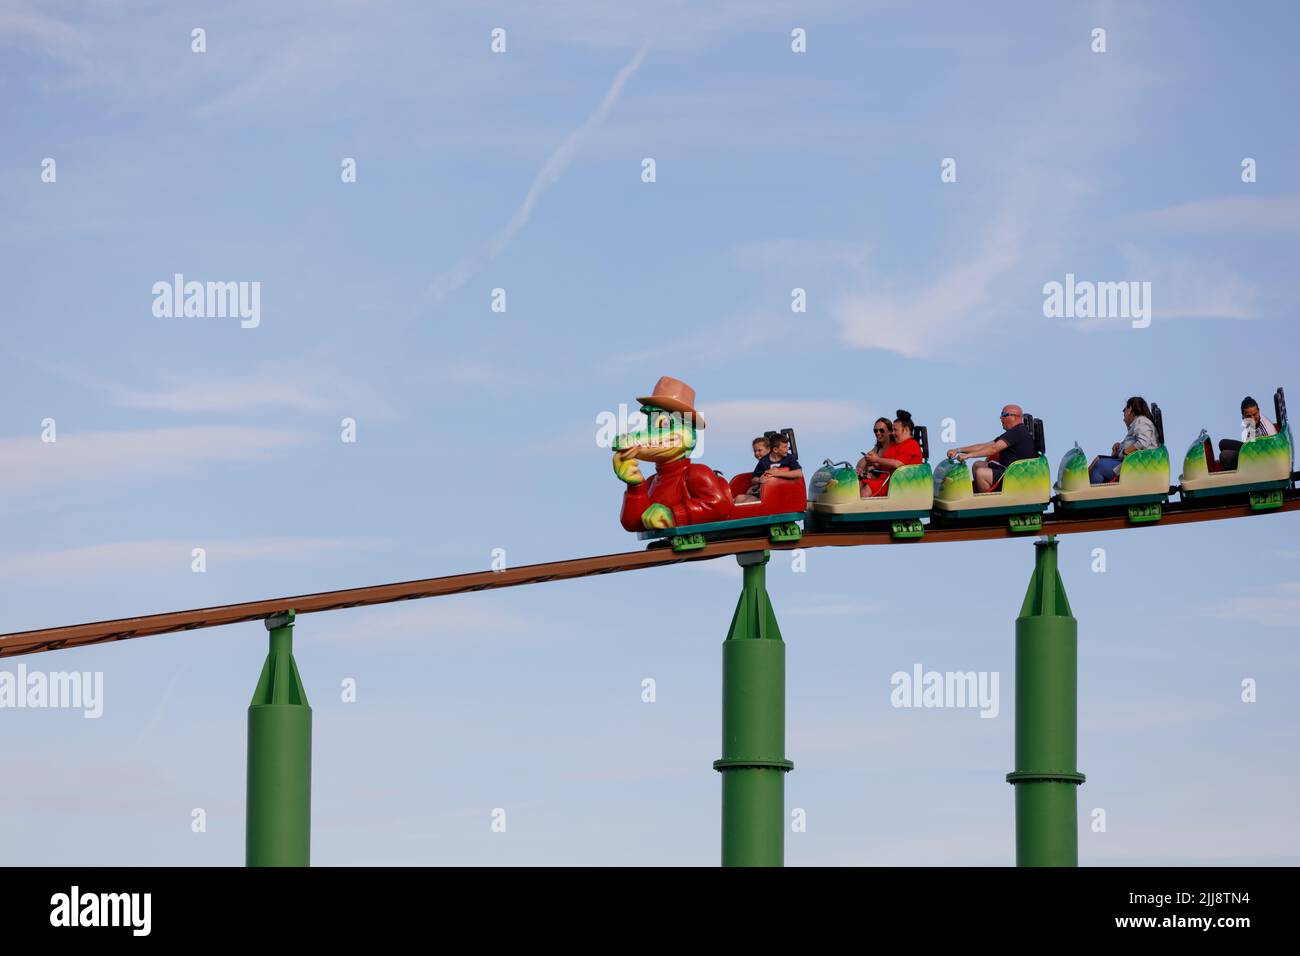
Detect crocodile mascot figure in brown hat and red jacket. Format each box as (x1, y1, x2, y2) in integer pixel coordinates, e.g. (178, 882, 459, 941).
(614, 376, 733, 531)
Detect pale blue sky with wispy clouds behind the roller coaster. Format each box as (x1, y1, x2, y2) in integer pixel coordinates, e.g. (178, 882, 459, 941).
(0, 0, 1300, 865)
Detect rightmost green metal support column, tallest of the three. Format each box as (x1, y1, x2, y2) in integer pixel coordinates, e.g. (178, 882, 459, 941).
(1006, 536, 1084, 866)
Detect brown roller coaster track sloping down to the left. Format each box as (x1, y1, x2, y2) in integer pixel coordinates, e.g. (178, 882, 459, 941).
(0, 490, 1300, 657)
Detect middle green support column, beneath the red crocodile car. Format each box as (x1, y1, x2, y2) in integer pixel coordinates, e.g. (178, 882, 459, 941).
(714, 551, 794, 866)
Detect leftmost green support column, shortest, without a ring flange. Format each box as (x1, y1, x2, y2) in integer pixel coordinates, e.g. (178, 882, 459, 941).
(244, 611, 312, 866)
